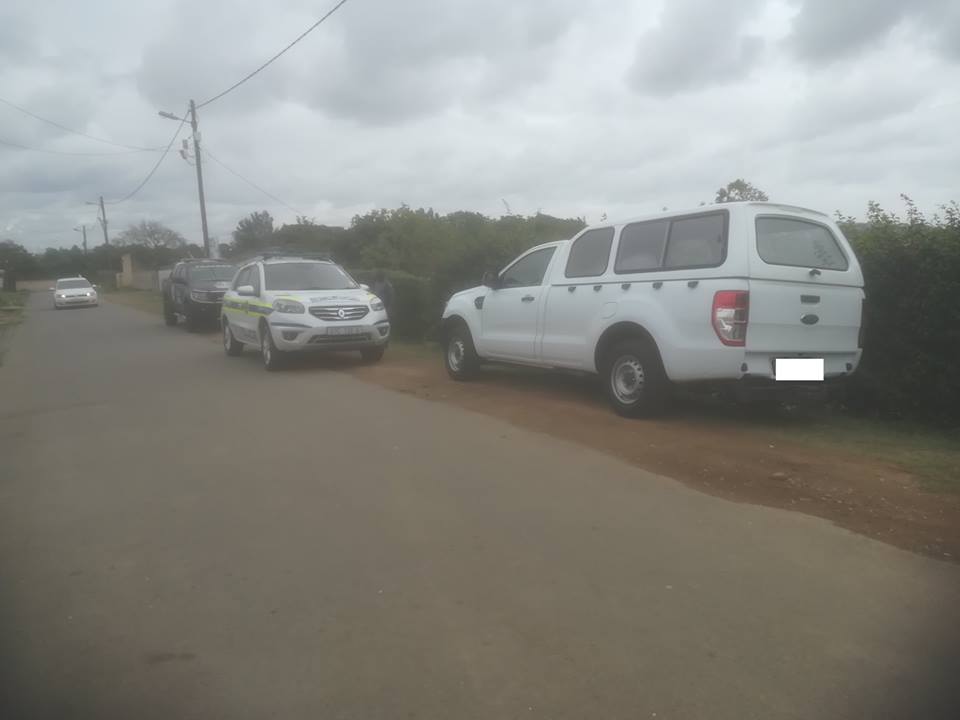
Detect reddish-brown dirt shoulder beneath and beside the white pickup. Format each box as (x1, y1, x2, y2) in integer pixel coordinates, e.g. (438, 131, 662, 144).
(343, 346, 960, 562)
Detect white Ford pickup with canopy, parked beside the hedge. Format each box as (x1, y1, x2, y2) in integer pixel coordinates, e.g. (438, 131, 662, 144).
(443, 202, 864, 416)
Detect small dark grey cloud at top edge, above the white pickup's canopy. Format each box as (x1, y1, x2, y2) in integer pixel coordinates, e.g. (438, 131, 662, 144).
(628, 0, 763, 95)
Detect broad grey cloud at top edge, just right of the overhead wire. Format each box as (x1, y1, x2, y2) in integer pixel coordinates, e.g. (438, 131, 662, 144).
(298, 0, 592, 123)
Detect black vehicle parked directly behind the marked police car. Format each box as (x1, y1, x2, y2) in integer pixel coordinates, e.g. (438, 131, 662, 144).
(162, 260, 236, 331)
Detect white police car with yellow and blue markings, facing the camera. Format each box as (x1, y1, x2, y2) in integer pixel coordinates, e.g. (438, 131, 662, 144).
(220, 254, 390, 370)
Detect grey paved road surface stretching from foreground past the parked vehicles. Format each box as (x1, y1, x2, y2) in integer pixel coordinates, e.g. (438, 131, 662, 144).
(0, 295, 960, 720)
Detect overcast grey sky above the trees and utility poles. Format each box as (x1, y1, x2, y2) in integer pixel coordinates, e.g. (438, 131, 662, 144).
(0, 0, 960, 250)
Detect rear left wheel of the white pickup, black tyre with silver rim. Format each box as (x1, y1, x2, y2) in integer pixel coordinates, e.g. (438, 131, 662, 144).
(601, 339, 670, 417)
